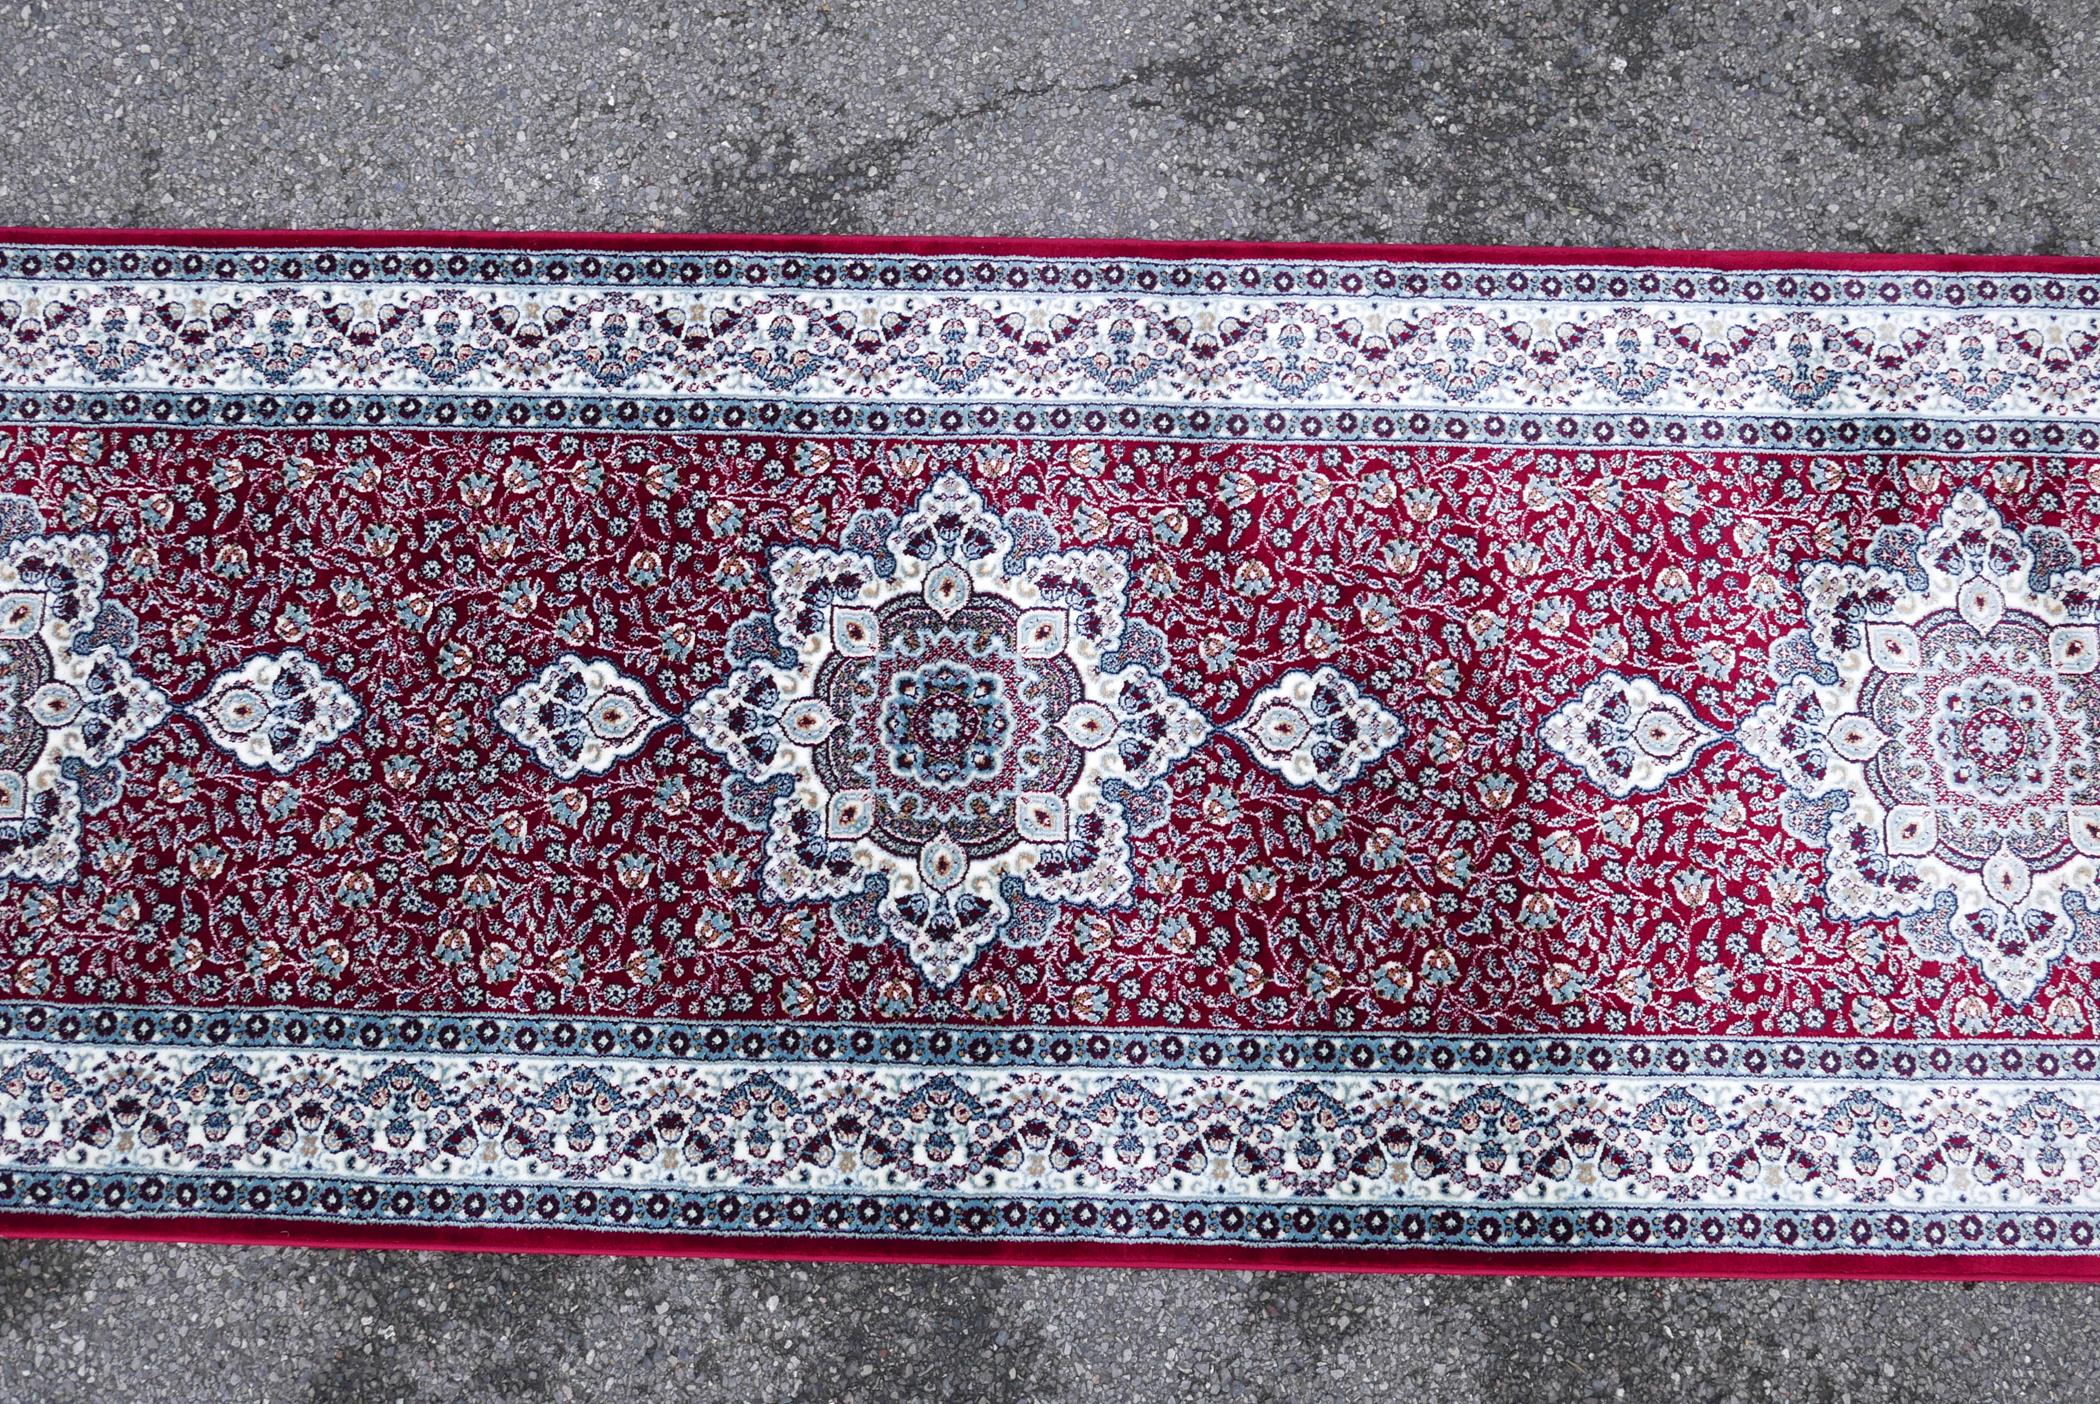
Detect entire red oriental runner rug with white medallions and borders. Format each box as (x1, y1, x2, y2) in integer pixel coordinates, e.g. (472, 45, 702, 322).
(0, 231, 2100, 1276)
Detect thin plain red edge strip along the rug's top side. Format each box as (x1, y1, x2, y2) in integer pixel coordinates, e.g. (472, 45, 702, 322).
(0, 227, 2100, 275)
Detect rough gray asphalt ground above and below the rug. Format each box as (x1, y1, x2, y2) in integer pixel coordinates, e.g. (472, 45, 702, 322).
(0, 0, 2100, 1404)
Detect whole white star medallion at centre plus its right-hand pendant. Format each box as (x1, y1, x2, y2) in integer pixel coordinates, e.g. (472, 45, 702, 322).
(688, 472, 1401, 986)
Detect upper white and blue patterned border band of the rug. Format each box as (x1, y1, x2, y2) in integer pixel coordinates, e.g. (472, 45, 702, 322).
(12, 233, 2100, 453)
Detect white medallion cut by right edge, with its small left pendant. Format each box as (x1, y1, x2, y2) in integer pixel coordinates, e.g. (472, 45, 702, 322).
(1541, 489, 2100, 1005)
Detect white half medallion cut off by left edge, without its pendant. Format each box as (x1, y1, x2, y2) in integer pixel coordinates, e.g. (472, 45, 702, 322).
(0, 497, 168, 884)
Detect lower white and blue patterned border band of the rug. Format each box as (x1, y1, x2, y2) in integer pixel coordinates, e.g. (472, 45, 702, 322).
(12, 1005, 2100, 1257)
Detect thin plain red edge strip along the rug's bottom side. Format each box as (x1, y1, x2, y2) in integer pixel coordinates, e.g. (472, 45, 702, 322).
(0, 1213, 2100, 1282)
